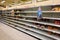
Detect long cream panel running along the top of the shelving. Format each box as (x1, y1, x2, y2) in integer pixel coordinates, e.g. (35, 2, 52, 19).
(3, 0, 60, 10)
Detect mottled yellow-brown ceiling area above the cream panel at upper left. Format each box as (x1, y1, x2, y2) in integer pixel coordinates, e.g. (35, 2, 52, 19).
(0, 0, 29, 7)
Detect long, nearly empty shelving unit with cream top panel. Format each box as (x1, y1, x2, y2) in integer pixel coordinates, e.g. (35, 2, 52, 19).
(1, 0, 60, 40)
